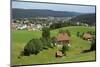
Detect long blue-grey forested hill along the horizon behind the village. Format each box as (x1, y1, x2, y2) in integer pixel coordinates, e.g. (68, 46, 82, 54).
(12, 8, 81, 18)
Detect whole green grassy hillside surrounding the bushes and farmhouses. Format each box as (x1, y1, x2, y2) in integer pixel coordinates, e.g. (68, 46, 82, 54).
(12, 26, 95, 65)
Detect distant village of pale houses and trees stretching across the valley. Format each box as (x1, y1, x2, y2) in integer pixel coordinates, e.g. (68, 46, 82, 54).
(11, 17, 89, 31)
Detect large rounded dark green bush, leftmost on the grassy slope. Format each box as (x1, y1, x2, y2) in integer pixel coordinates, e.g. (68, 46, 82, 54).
(24, 39, 43, 56)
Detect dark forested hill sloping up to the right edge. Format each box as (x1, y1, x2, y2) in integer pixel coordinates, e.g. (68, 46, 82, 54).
(71, 13, 96, 25)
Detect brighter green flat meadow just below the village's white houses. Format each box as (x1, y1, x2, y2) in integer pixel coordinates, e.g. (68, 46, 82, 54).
(12, 30, 42, 43)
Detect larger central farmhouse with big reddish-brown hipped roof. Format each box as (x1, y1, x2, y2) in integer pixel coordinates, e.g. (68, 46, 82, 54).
(57, 33, 70, 44)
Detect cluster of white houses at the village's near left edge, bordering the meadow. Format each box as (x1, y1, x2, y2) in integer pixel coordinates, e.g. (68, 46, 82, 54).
(11, 21, 43, 31)
